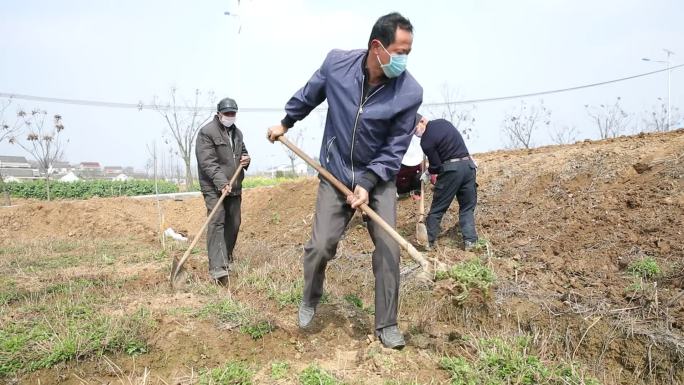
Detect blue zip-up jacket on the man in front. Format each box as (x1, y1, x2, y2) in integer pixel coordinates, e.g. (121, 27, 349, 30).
(283, 50, 423, 191)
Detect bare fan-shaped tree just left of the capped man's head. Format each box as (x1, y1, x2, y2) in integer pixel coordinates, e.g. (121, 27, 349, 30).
(152, 87, 214, 188)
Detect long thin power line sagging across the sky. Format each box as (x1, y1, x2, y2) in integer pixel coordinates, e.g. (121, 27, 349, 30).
(0, 64, 684, 112)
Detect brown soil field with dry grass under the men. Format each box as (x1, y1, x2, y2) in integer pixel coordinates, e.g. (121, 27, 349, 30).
(0, 130, 684, 384)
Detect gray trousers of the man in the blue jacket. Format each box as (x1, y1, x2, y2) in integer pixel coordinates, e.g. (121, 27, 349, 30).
(302, 179, 400, 330)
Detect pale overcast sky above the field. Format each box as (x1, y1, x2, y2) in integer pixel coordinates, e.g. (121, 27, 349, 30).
(0, 0, 684, 169)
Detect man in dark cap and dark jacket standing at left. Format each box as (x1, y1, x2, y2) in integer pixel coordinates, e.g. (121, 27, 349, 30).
(195, 98, 250, 286)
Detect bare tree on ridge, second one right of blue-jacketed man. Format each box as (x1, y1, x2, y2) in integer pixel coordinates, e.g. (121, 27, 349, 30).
(501, 100, 551, 148)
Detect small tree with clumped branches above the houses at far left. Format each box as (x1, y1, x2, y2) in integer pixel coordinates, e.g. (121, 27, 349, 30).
(10, 109, 64, 201)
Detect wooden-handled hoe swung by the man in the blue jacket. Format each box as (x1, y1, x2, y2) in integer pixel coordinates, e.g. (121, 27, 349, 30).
(278, 135, 446, 280)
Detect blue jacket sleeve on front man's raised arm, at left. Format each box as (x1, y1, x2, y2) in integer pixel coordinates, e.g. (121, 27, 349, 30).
(281, 51, 334, 128)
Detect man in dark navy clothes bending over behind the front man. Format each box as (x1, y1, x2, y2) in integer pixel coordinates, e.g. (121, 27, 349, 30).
(416, 115, 477, 250)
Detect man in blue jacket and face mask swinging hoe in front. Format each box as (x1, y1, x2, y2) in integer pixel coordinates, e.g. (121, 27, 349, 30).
(268, 13, 423, 349)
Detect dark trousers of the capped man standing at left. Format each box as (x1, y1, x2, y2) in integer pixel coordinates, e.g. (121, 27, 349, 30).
(202, 190, 242, 279)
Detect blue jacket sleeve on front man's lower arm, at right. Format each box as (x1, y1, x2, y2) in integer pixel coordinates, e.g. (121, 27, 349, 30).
(360, 90, 423, 187)
